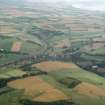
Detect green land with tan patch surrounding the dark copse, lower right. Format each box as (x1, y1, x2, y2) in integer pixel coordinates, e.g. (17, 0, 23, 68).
(33, 61, 105, 105)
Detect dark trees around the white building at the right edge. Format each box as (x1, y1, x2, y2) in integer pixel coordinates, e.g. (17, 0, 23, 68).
(73, 53, 105, 76)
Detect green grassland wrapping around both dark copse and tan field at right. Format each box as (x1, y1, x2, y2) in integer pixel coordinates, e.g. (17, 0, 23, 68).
(41, 63, 105, 105)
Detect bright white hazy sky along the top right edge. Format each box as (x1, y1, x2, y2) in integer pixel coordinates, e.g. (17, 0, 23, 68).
(28, 0, 105, 11)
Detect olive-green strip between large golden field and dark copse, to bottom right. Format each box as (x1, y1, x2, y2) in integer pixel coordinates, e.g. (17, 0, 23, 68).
(41, 76, 105, 105)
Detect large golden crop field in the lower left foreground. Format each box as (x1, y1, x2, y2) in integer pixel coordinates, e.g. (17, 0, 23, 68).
(8, 76, 68, 102)
